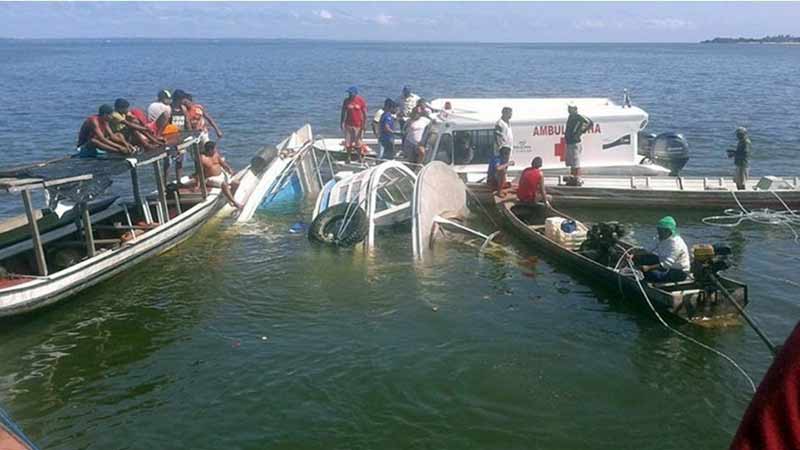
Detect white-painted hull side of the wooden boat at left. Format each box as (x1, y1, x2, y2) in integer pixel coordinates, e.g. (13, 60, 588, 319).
(0, 190, 225, 317)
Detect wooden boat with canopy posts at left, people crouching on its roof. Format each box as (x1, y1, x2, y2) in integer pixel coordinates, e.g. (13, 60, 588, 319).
(0, 132, 282, 316)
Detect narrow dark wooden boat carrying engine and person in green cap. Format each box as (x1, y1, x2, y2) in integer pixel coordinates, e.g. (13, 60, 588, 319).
(497, 200, 748, 325)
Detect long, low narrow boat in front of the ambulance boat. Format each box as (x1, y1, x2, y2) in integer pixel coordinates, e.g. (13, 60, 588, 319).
(468, 173, 800, 211)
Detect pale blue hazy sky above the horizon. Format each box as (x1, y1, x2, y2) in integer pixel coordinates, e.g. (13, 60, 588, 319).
(0, 2, 800, 42)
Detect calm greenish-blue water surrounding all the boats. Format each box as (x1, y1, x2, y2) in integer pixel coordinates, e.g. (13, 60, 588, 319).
(0, 41, 800, 449)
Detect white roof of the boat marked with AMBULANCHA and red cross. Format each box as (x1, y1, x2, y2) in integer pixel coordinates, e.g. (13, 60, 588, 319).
(430, 97, 648, 125)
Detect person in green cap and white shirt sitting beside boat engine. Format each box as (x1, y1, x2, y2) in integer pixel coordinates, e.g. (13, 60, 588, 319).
(641, 216, 691, 283)
